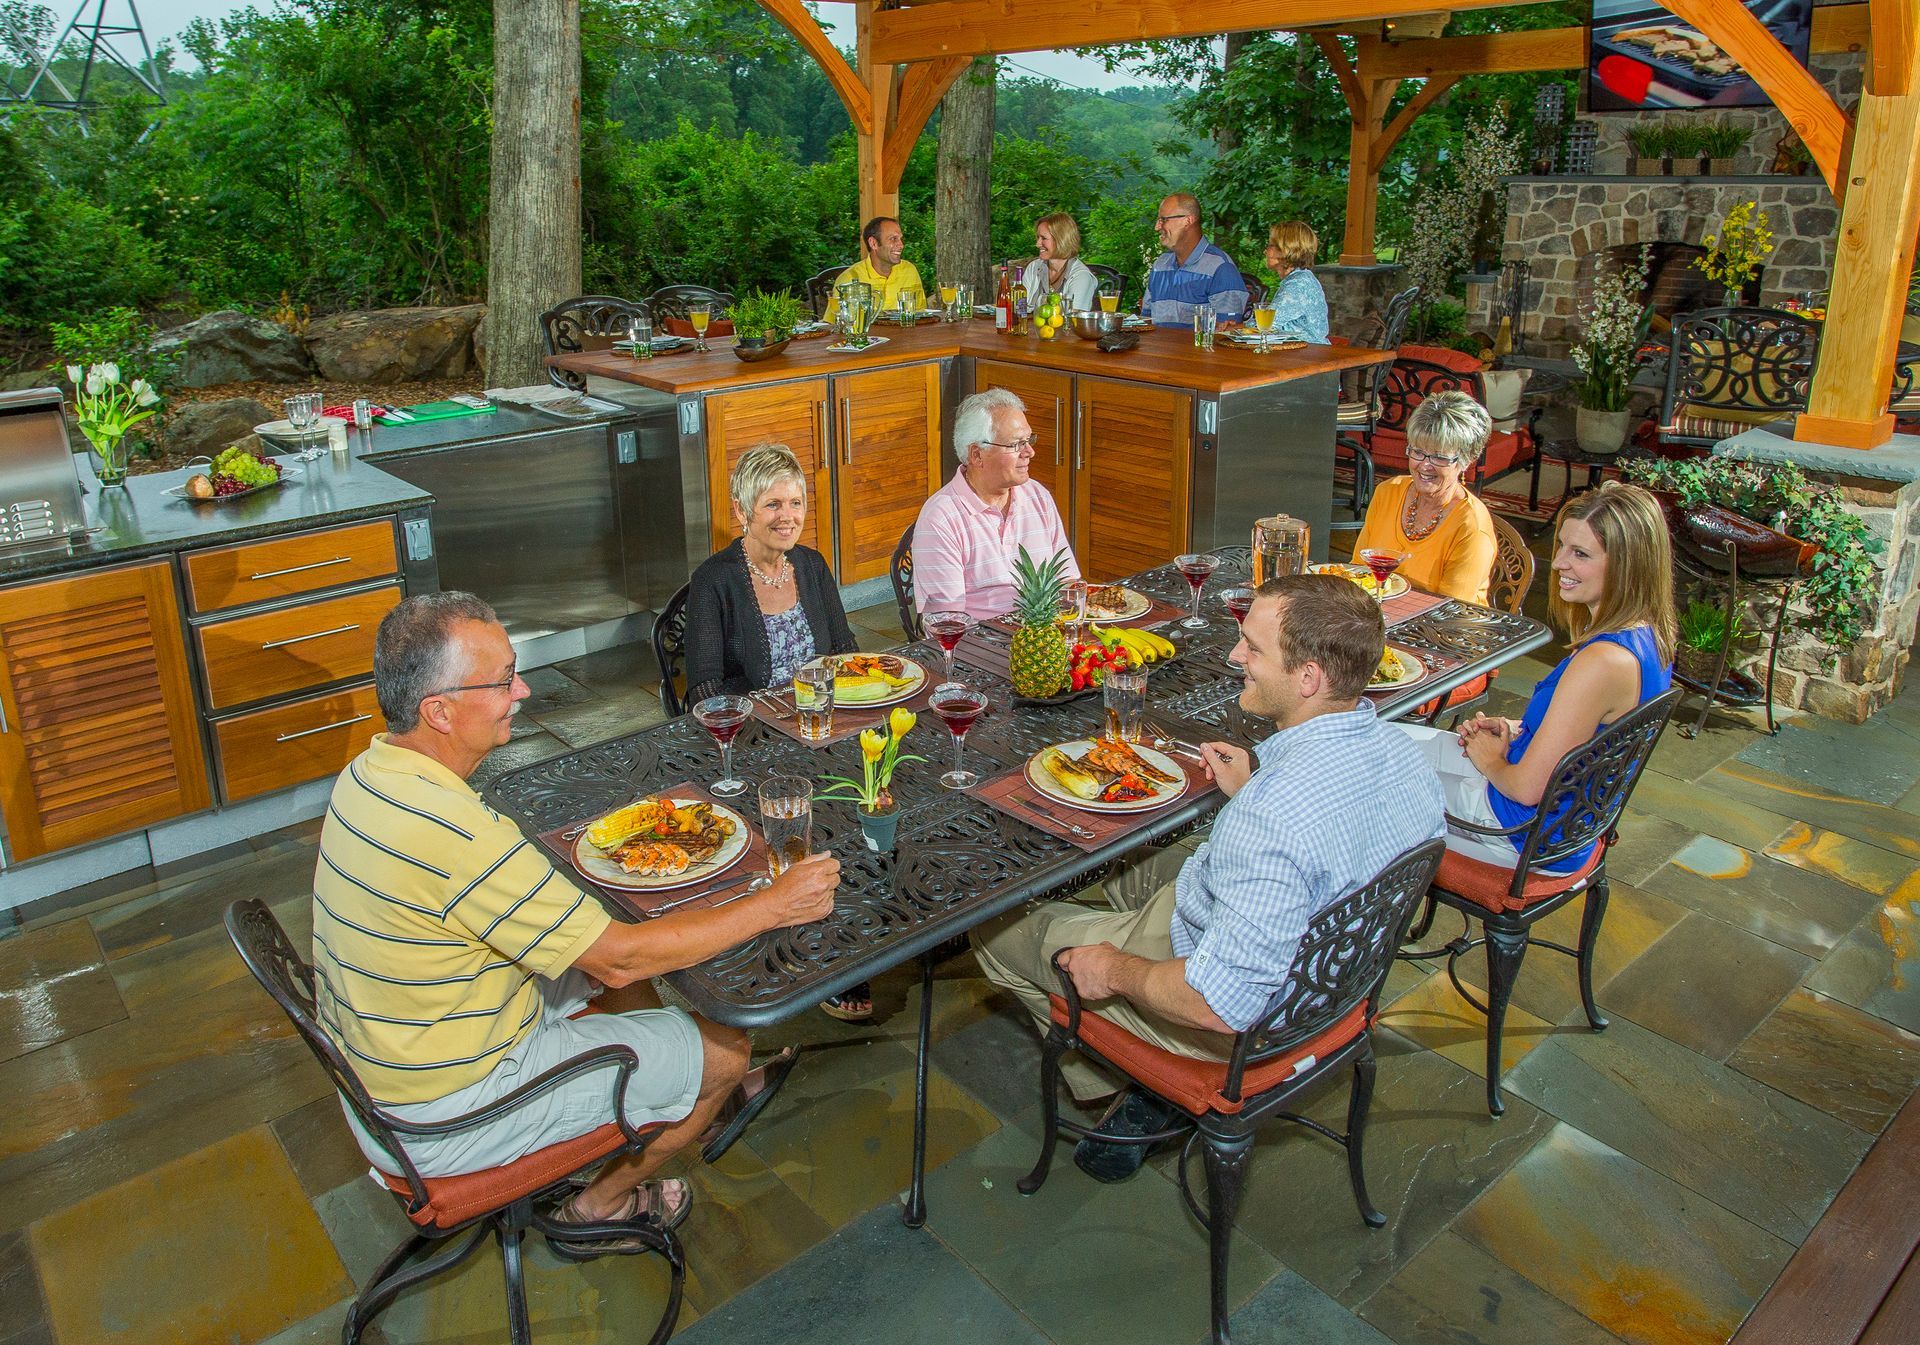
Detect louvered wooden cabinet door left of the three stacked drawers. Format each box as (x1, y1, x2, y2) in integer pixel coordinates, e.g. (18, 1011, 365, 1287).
(0, 560, 209, 860)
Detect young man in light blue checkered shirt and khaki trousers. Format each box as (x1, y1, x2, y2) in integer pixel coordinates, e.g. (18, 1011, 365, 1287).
(973, 574, 1446, 1182)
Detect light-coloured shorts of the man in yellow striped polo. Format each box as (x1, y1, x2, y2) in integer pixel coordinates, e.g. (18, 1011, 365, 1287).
(340, 971, 701, 1176)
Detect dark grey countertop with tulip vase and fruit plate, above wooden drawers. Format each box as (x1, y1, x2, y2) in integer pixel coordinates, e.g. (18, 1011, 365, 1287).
(0, 453, 434, 583)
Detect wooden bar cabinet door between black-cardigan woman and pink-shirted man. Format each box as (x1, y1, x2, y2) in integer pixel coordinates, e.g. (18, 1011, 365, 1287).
(833, 365, 941, 583)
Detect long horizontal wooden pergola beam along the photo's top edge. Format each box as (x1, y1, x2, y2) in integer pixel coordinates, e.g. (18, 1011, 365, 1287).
(862, 0, 1540, 63)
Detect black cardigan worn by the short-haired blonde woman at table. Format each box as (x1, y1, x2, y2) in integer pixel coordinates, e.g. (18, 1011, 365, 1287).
(687, 537, 858, 706)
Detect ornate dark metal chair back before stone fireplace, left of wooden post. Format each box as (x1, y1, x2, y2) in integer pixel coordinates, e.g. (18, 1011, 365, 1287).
(1655, 309, 1820, 449)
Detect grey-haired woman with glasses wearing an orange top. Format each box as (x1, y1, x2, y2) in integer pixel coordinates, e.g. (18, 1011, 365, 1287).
(1354, 391, 1500, 602)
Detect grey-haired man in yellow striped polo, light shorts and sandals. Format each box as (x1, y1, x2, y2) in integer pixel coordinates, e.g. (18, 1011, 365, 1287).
(313, 593, 839, 1224)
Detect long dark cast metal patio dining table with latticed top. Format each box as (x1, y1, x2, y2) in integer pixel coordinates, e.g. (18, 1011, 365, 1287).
(486, 547, 1549, 1228)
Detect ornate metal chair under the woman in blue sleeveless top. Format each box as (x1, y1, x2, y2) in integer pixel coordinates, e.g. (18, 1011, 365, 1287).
(1400, 689, 1682, 1117)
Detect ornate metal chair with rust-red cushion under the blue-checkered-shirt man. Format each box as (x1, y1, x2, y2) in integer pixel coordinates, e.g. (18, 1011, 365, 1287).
(1020, 840, 1444, 1345)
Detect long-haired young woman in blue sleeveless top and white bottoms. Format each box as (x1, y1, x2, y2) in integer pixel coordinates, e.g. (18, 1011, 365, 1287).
(1404, 482, 1676, 871)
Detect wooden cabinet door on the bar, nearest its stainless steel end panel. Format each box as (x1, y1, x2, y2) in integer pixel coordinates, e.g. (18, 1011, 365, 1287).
(1073, 378, 1192, 581)
